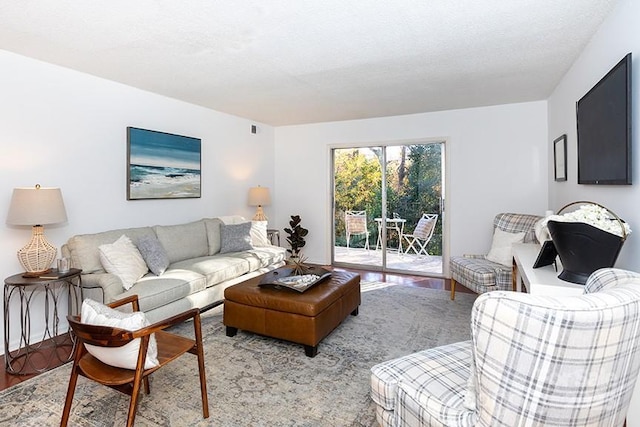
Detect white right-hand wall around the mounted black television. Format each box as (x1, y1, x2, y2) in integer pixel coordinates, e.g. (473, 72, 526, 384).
(548, 0, 640, 271)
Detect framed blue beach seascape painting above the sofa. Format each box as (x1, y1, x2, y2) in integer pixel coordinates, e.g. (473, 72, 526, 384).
(127, 127, 201, 200)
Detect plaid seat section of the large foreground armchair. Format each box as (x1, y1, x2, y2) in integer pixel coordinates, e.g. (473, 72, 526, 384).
(371, 341, 473, 427)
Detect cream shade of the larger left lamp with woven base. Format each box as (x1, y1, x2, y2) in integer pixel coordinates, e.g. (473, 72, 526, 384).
(7, 185, 67, 225)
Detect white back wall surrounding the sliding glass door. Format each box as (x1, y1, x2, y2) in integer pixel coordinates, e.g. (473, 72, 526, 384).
(274, 102, 549, 270)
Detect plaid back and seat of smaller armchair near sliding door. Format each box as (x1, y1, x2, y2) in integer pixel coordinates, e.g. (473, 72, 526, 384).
(449, 213, 542, 294)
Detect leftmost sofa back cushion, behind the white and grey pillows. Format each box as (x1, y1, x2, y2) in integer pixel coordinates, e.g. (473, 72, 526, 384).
(66, 227, 155, 274)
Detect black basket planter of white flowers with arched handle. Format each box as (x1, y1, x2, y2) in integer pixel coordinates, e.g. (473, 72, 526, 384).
(546, 202, 631, 285)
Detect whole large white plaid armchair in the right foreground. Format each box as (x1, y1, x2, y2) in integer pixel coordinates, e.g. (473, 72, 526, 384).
(371, 268, 640, 427)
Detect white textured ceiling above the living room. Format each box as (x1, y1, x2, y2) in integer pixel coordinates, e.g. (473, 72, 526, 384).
(0, 0, 616, 126)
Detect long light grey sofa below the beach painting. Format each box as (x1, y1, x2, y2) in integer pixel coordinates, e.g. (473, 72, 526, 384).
(61, 216, 286, 322)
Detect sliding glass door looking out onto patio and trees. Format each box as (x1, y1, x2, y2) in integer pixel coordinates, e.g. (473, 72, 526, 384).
(332, 141, 444, 276)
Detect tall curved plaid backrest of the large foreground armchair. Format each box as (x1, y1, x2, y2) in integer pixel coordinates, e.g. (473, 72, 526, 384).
(471, 269, 640, 427)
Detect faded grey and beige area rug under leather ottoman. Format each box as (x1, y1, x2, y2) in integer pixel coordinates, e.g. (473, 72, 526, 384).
(0, 282, 475, 427)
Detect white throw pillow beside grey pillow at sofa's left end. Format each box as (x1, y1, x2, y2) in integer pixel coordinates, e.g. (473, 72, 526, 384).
(98, 234, 149, 290)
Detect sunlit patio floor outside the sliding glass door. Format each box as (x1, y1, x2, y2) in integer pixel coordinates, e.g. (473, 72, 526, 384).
(334, 246, 442, 275)
